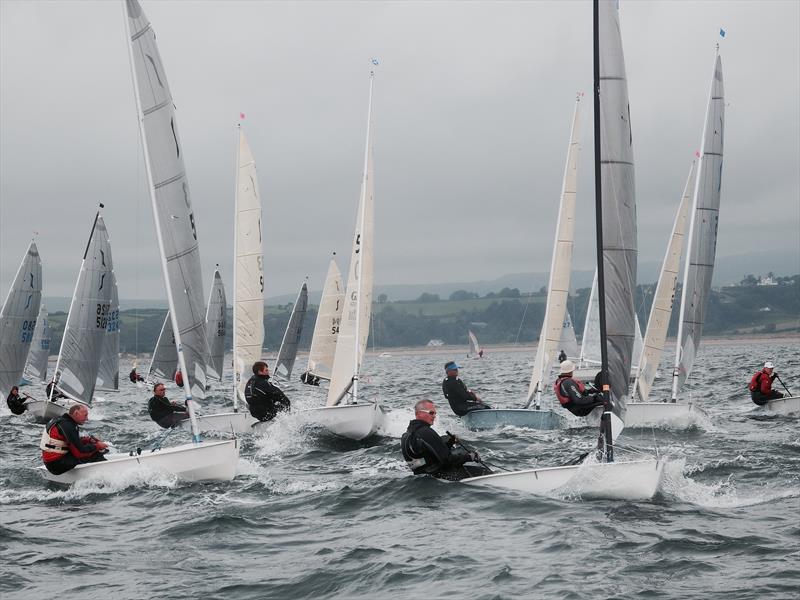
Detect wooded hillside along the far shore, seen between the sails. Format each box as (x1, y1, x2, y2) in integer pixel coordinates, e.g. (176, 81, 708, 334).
(50, 275, 800, 354)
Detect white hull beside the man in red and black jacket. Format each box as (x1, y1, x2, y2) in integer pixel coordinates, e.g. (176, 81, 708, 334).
(39, 439, 239, 484)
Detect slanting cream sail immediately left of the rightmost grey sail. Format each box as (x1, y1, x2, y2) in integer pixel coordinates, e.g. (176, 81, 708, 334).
(633, 161, 697, 402)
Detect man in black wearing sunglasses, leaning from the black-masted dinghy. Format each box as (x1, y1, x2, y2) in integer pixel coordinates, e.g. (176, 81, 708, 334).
(400, 400, 492, 481)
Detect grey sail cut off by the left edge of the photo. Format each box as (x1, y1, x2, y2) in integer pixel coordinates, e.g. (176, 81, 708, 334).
(0, 242, 42, 395)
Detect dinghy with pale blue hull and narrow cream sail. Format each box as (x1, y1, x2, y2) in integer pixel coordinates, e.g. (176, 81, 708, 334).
(461, 95, 581, 430)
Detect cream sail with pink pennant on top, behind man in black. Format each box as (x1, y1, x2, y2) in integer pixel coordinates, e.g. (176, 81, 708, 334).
(233, 127, 264, 410)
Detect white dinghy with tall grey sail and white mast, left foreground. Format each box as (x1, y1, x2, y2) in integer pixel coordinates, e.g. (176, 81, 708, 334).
(40, 0, 239, 483)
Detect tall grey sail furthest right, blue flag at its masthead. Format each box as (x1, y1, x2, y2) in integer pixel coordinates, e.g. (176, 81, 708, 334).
(672, 53, 725, 402)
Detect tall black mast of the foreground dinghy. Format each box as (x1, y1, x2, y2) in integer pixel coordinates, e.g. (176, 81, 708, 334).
(593, 0, 614, 462)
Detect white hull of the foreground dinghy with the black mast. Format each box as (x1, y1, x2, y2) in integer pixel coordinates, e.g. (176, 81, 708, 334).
(461, 459, 664, 500)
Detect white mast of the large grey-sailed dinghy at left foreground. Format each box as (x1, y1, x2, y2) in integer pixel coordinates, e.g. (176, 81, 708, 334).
(124, 4, 200, 443)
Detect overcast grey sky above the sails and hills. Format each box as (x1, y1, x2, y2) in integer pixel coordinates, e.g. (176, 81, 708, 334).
(0, 0, 800, 301)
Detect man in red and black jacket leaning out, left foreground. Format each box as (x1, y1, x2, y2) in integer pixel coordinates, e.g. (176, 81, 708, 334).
(39, 404, 108, 475)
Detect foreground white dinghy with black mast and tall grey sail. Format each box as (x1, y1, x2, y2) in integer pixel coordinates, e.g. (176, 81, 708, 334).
(461, 0, 664, 500)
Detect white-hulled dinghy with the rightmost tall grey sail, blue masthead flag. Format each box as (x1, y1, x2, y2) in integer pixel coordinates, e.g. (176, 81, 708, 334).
(628, 48, 725, 428)
